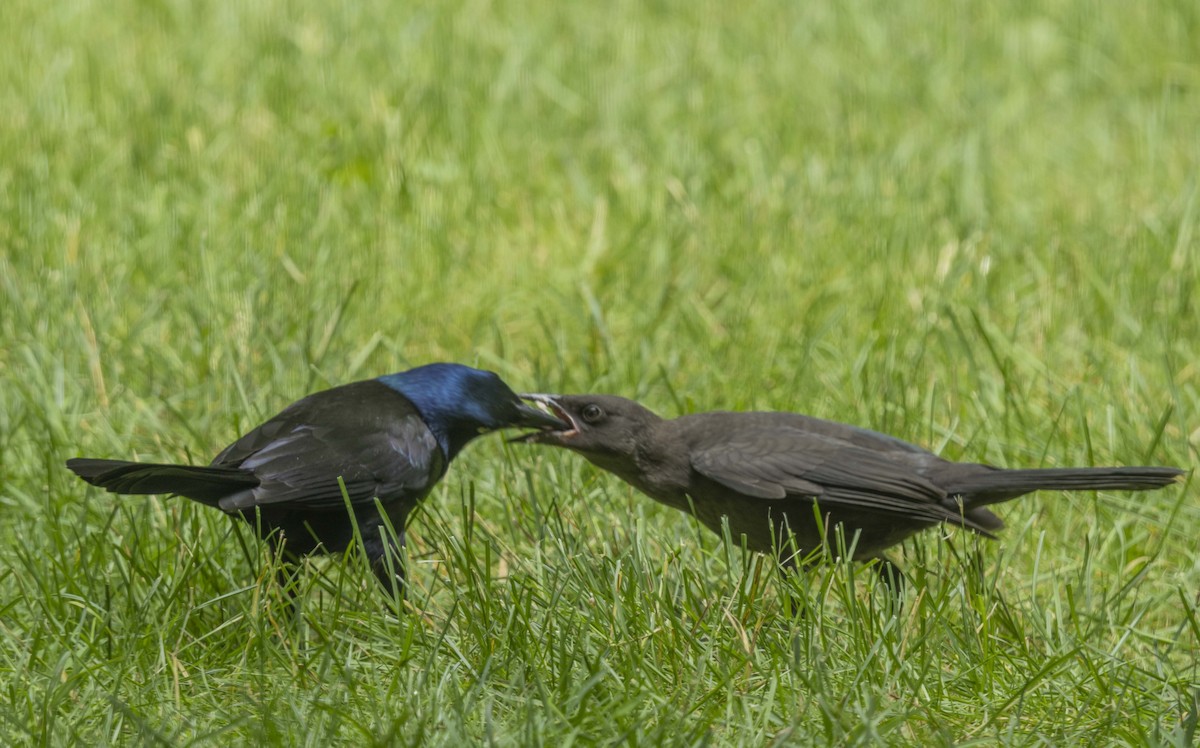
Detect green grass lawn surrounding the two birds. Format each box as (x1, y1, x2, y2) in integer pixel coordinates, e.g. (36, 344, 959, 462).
(0, 0, 1200, 747)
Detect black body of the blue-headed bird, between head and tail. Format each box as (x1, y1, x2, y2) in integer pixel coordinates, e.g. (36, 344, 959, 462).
(212, 381, 449, 555)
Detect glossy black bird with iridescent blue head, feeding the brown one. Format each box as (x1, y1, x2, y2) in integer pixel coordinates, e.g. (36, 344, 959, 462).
(67, 364, 566, 602)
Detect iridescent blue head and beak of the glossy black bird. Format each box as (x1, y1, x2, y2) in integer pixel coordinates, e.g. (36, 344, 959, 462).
(379, 364, 570, 460)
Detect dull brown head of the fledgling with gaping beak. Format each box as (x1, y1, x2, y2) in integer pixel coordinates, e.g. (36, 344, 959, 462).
(511, 395, 661, 467)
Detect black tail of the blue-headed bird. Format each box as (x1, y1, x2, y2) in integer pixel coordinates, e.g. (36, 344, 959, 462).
(67, 457, 258, 507)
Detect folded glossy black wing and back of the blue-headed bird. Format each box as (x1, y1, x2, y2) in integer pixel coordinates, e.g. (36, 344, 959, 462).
(212, 381, 449, 513)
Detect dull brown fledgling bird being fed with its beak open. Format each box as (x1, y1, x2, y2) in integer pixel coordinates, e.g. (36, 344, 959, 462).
(512, 395, 1184, 582)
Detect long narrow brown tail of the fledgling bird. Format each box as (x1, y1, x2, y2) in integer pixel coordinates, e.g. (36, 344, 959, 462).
(946, 466, 1187, 509)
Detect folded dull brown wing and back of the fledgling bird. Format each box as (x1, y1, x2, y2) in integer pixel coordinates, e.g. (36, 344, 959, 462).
(689, 413, 986, 531)
